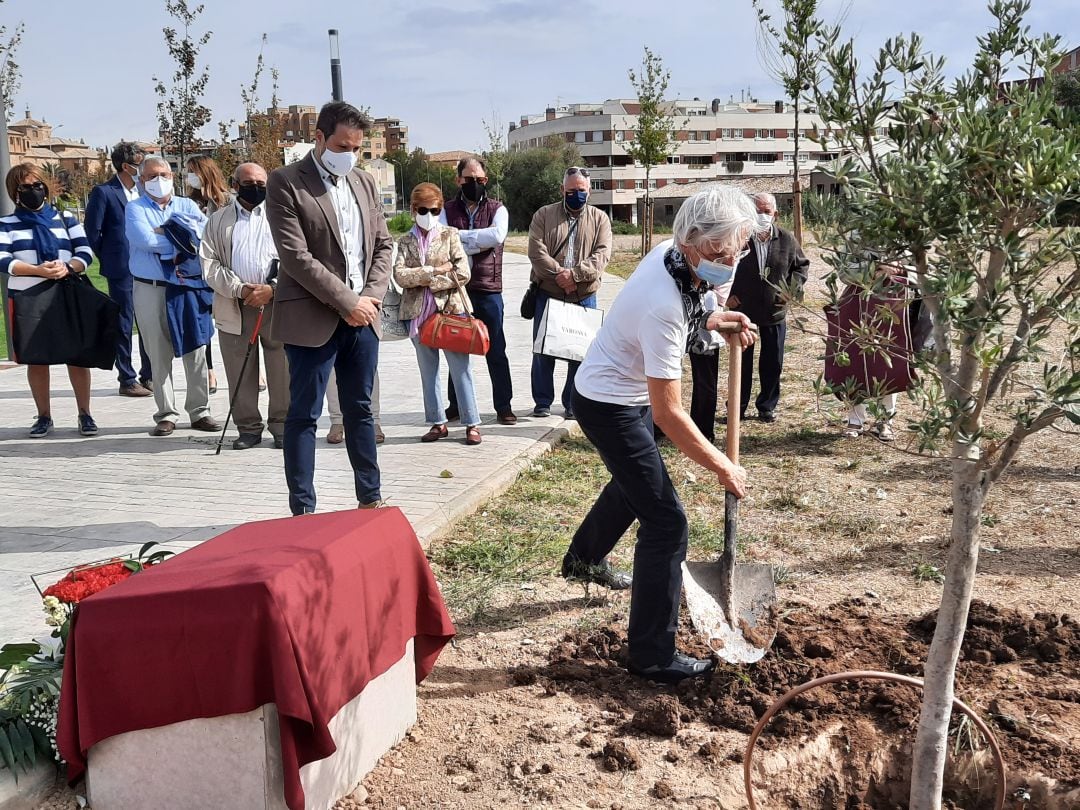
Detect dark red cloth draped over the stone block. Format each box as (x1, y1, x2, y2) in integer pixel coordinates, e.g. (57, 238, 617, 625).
(56, 509, 454, 810)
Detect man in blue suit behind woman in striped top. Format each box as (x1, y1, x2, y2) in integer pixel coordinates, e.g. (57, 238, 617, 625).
(84, 147, 153, 396)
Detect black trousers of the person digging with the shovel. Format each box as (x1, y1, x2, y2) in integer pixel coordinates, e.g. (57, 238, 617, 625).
(569, 391, 689, 667)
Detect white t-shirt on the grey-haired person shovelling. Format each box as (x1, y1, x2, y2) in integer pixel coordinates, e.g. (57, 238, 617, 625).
(573, 240, 687, 406)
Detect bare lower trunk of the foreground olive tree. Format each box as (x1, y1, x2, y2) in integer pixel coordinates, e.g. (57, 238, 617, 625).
(909, 446, 986, 810)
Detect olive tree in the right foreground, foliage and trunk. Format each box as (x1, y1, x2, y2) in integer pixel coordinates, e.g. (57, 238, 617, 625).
(794, 0, 1080, 810)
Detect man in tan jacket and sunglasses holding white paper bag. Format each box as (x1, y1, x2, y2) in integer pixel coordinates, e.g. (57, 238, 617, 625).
(529, 166, 611, 419)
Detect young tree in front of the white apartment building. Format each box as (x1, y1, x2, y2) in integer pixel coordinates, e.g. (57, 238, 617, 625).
(624, 48, 675, 255)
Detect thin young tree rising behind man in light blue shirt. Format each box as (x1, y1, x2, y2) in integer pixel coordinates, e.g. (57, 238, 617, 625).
(153, 0, 213, 191)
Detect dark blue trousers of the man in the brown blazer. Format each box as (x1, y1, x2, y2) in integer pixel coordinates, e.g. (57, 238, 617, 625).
(284, 321, 382, 515)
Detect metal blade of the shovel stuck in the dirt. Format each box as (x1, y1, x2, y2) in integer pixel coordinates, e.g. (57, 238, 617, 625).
(683, 563, 778, 664)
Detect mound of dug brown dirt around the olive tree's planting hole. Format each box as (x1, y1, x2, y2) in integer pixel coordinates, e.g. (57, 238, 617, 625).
(533, 599, 1080, 785)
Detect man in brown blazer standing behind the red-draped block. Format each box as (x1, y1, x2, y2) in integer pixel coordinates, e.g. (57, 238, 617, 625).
(267, 102, 393, 515)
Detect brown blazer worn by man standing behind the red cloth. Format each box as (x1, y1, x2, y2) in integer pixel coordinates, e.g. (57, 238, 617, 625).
(267, 153, 393, 347)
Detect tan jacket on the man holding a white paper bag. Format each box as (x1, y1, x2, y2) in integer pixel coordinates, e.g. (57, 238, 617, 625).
(529, 201, 611, 301)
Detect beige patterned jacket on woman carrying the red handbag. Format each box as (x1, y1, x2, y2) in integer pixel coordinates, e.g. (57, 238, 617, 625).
(394, 225, 472, 321)
